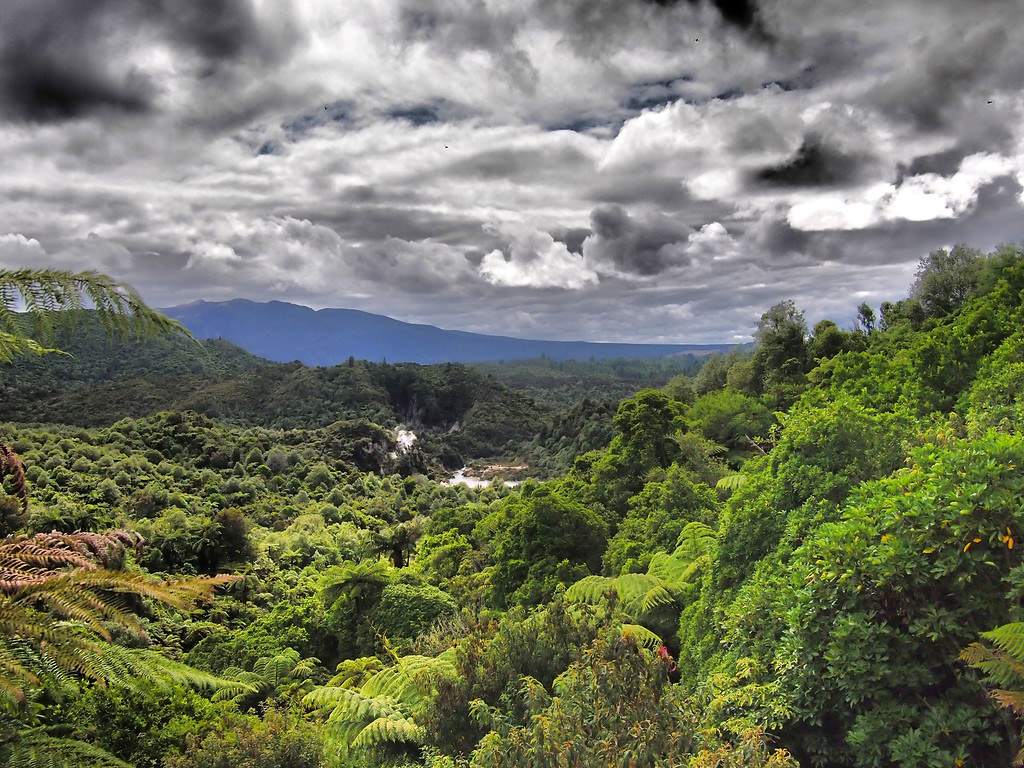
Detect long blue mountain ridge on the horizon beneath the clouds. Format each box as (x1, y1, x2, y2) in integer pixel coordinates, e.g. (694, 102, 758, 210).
(161, 299, 732, 366)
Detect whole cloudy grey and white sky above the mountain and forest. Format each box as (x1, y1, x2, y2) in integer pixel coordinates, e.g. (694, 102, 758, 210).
(0, 0, 1024, 343)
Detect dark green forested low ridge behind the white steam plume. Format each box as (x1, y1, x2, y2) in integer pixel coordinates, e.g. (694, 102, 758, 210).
(0, 322, 545, 467)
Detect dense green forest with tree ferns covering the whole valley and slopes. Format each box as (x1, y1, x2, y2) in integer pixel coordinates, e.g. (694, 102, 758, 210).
(6, 246, 1024, 768)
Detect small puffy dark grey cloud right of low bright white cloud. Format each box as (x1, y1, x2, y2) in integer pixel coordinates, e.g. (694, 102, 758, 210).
(583, 205, 691, 275)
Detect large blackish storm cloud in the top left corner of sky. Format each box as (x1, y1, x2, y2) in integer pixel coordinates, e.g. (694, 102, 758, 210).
(0, 0, 282, 122)
